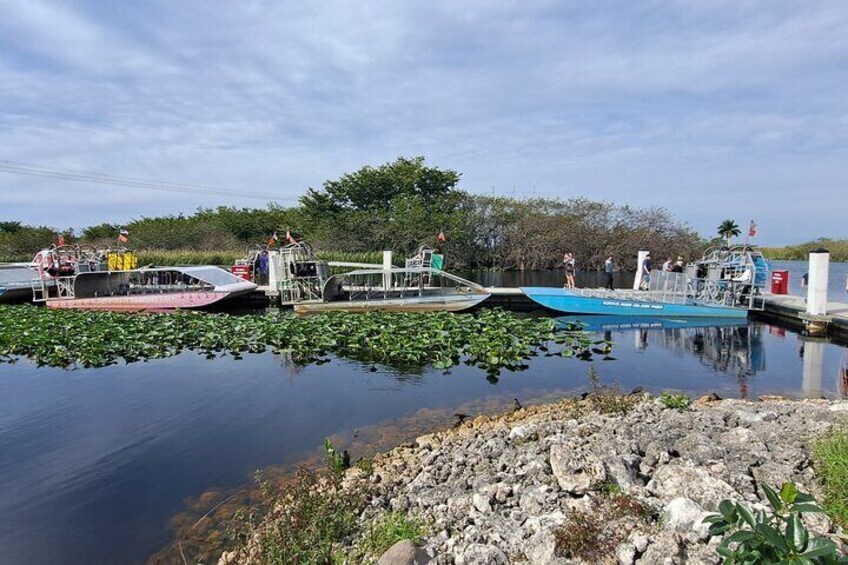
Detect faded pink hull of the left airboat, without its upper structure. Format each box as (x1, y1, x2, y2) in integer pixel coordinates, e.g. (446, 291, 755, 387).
(47, 291, 241, 312)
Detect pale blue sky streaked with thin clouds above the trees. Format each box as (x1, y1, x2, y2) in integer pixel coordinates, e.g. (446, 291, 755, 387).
(0, 0, 848, 245)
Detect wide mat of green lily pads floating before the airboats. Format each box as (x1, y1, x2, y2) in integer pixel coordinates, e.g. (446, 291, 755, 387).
(0, 305, 610, 372)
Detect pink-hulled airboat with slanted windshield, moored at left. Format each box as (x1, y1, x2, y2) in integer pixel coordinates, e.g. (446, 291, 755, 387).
(30, 245, 257, 312)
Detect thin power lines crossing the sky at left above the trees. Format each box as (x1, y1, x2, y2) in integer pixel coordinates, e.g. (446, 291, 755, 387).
(0, 161, 296, 201)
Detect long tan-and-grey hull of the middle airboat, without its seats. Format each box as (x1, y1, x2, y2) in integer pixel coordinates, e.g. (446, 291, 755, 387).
(293, 294, 489, 314)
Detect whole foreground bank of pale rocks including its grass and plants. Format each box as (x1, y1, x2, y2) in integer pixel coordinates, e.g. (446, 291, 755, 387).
(219, 392, 848, 565)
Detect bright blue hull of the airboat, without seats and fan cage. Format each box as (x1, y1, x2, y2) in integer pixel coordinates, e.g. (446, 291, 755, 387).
(521, 287, 748, 318)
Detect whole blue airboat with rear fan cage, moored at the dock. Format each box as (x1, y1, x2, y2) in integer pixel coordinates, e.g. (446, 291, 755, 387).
(521, 246, 769, 318)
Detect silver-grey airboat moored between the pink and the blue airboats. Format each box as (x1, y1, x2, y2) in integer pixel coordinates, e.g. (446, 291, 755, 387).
(233, 241, 489, 314)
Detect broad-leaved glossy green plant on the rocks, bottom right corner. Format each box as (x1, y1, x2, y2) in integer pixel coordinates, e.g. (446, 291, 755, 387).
(704, 483, 848, 565)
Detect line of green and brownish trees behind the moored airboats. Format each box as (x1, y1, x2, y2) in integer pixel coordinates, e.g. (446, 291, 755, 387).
(0, 157, 704, 270)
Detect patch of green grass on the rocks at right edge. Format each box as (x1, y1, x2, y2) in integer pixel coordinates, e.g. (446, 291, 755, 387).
(813, 429, 848, 529)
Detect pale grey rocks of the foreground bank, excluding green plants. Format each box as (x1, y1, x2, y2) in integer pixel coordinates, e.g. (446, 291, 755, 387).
(221, 395, 848, 565)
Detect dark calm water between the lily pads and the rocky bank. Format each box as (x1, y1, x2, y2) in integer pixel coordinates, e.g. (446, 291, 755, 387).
(0, 258, 848, 565)
